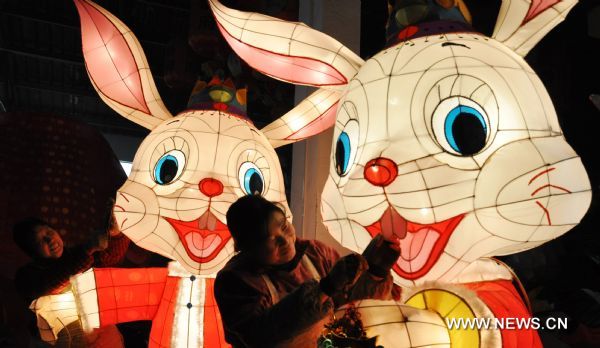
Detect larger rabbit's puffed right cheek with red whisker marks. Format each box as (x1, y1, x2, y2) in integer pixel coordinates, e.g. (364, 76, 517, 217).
(475, 137, 591, 254)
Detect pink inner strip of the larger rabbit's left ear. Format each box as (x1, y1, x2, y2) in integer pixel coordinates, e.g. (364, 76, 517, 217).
(217, 23, 348, 86)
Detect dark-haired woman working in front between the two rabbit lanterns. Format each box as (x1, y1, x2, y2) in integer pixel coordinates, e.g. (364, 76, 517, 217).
(214, 195, 400, 347)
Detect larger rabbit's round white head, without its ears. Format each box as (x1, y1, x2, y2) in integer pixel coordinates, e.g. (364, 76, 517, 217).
(322, 34, 591, 286)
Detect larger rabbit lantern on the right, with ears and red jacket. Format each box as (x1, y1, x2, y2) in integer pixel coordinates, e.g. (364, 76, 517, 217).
(209, 0, 591, 346)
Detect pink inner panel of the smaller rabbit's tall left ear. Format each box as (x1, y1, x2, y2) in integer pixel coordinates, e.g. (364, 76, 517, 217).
(75, 0, 150, 114)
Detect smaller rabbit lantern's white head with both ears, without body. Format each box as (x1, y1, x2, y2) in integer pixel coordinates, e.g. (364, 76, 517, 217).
(76, 0, 340, 276)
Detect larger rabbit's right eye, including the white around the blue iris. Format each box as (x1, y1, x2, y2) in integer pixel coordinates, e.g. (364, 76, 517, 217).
(434, 98, 490, 156)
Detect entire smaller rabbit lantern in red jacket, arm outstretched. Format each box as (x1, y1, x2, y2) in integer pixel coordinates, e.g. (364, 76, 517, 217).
(64, 0, 340, 347)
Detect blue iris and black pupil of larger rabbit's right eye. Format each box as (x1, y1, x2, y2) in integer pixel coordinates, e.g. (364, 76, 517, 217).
(444, 105, 489, 156)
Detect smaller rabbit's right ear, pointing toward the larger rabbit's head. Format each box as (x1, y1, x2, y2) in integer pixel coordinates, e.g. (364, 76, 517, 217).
(261, 88, 342, 148)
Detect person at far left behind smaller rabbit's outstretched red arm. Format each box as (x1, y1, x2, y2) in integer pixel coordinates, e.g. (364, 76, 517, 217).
(13, 216, 130, 347)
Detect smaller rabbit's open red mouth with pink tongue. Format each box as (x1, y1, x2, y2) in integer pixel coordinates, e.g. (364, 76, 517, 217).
(164, 210, 231, 263)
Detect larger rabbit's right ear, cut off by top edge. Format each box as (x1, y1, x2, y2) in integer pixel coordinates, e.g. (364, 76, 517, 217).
(492, 0, 577, 57)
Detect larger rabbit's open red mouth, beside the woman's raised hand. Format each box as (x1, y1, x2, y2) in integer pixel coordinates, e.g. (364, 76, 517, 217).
(366, 206, 464, 280)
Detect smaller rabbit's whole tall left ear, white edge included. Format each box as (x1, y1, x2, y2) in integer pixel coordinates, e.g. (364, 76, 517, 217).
(75, 0, 173, 129)
